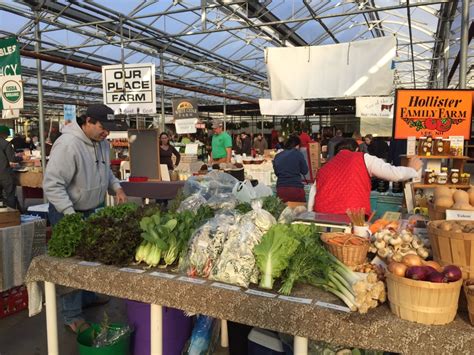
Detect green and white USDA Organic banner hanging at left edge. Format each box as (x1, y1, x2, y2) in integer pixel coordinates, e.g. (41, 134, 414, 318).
(0, 37, 23, 110)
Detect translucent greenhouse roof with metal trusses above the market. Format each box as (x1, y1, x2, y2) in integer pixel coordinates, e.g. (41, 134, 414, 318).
(0, 0, 474, 116)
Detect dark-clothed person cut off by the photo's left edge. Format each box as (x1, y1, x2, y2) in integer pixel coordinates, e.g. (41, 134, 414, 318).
(0, 126, 23, 208)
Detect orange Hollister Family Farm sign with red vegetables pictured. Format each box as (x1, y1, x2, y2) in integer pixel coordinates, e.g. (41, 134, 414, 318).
(394, 89, 474, 139)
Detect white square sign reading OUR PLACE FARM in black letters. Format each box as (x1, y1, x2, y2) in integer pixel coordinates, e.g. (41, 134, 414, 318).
(102, 63, 156, 114)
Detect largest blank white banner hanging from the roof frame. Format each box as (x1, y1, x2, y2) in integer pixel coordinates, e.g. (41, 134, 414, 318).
(265, 36, 396, 100)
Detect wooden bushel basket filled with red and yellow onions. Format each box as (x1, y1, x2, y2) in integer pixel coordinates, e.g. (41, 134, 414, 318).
(386, 254, 462, 325)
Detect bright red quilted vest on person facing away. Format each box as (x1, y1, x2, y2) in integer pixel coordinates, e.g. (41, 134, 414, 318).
(314, 150, 371, 214)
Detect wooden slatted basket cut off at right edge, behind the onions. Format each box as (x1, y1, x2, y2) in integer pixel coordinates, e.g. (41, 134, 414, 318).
(428, 221, 474, 279)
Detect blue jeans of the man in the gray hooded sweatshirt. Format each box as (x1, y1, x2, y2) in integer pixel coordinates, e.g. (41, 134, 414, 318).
(48, 203, 97, 324)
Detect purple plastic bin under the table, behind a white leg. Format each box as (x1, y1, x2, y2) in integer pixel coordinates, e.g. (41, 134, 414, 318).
(126, 300, 192, 355)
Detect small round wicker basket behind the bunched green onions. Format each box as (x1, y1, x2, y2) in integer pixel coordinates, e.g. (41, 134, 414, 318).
(321, 232, 370, 266)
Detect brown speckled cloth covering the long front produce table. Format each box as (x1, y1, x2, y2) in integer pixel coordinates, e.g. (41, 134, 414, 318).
(26, 256, 474, 354)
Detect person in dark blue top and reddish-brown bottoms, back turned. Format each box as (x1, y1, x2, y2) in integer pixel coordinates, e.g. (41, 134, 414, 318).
(273, 136, 308, 202)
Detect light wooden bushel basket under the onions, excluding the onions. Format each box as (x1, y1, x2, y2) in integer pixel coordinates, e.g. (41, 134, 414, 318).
(386, 273, 462, 325)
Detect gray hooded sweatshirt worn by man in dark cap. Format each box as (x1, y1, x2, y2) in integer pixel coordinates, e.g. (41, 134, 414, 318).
(43, 122, 120, 214)
